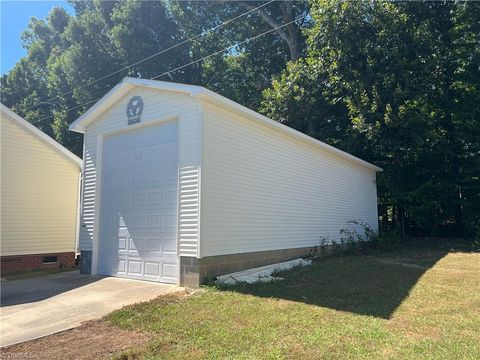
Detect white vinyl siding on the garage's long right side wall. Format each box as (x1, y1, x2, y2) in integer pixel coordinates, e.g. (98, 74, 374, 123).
(201, 103, 378, 257)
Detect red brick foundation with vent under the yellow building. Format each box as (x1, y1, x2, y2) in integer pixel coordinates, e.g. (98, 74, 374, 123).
(0, 252, 75, 276)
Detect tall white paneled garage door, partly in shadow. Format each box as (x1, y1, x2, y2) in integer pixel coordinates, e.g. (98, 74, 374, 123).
(98, 122, 178, 283)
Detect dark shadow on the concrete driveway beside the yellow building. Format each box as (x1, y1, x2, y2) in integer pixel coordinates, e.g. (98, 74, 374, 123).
(0, 270, 102, 307)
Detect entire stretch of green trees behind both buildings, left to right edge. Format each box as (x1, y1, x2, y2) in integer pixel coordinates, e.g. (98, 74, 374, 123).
(1, 0, 480, 235)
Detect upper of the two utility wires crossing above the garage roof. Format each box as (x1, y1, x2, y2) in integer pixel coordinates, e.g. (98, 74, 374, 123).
(25, 0, 275, 111)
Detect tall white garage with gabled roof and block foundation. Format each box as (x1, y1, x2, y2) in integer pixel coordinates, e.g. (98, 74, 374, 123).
(70, 78, 381, 286)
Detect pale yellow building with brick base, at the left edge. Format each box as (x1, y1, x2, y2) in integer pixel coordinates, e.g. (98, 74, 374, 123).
(0, 104, 82, 276)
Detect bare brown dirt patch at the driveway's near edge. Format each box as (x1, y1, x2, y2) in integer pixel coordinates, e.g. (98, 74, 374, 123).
(0, 320, 152, 360)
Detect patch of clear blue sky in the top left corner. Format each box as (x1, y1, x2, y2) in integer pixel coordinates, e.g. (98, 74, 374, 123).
(0, 0, 73, 75)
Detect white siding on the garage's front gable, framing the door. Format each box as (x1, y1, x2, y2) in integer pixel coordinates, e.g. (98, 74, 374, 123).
(80, 87, 200, 256)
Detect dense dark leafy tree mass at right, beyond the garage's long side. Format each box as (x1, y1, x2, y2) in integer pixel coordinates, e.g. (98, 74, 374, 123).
(262, 1, 480, 235)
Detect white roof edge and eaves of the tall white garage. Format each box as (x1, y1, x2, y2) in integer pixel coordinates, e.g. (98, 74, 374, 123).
(70, 77, 382, 171)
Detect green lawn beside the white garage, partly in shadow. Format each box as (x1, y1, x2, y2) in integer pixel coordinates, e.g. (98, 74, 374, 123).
(107, 248, 480, 359)
